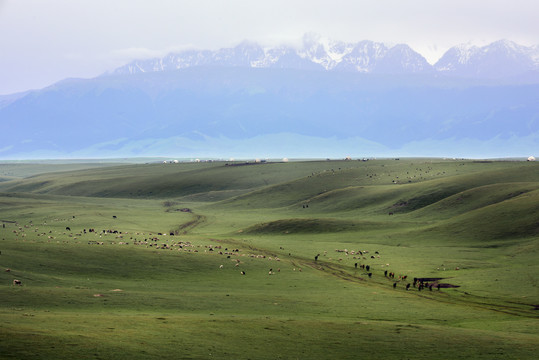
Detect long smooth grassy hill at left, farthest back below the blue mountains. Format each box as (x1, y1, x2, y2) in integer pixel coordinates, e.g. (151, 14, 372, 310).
(0, 162, 368, 200)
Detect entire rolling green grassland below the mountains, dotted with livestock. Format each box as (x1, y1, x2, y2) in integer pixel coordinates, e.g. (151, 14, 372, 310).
(0, 159, 539, 359)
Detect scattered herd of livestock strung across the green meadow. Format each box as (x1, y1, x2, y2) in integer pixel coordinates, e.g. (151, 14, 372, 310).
(0, 216, 458, 291)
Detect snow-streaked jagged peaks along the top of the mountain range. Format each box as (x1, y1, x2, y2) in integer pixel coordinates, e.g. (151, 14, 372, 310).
(111, 34, 539, 79)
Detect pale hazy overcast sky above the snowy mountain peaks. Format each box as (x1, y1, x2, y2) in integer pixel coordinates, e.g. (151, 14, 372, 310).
(0, 0, 539, 94)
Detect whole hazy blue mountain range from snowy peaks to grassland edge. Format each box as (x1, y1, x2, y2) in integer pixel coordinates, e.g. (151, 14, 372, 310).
(0, 38, 539, 159)
